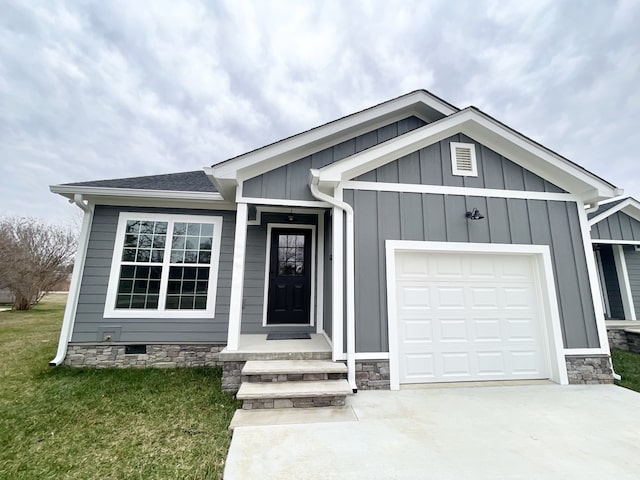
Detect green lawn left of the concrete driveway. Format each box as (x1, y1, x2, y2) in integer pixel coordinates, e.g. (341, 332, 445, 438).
(0, 295, 238, 480)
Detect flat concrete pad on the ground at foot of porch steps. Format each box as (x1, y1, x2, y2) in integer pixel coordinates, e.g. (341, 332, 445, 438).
(229, 406, 358, 430)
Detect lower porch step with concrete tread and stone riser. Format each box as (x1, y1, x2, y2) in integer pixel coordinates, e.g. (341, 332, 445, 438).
(236, 380, 352, 410)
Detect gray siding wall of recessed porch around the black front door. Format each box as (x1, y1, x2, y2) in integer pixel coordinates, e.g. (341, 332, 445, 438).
(241, 213, 318, 334)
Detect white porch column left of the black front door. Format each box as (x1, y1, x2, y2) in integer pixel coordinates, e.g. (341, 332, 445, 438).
(227, 203, 248, 350)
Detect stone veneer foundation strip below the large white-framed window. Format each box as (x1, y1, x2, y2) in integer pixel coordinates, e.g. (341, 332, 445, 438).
(64, 344, 225, 368)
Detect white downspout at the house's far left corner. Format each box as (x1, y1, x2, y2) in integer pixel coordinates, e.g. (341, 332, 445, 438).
(49, 193, 93, 367)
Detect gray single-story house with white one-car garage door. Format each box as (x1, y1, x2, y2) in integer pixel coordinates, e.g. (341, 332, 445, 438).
(51, 90, 621, 408)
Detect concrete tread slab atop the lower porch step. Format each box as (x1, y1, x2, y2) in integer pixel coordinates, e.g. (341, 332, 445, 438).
(236, 380, 353, 400)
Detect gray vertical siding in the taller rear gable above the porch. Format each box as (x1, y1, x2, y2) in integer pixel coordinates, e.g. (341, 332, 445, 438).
(242, 117, 425, 200)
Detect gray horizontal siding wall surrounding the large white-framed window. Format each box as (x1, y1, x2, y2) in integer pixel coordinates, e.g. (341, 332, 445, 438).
(71, 206, 235, 343)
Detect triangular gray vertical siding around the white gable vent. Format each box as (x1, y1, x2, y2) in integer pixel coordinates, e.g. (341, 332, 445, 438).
(354, 134, 564, 193)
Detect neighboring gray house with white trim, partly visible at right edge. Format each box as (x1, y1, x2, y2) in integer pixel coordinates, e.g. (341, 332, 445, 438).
(589, 197, 640, 351)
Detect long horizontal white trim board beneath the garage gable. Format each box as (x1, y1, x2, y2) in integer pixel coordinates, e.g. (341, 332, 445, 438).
(342, 180, 577, 202)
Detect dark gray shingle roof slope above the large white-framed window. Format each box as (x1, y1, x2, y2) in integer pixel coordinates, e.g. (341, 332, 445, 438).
(65, 170, 217, 192)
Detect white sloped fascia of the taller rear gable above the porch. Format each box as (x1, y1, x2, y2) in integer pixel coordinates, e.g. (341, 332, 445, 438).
(211, 91, 458, 179)
